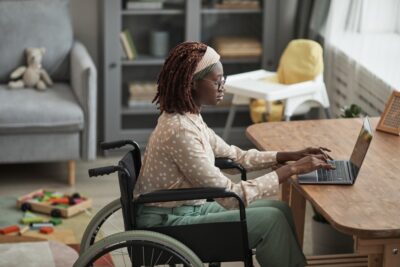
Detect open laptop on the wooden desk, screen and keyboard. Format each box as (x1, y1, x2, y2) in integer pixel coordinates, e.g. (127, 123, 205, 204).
(298, 117, 372, 185)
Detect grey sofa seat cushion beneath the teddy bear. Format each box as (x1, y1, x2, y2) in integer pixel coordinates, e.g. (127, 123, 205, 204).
(0, 83, 83, 134)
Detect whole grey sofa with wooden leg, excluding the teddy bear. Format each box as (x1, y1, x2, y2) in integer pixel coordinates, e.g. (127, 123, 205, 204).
(0, 0, 97, 185)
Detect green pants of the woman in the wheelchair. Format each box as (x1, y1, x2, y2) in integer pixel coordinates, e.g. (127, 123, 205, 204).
(137, 200, 306, 267)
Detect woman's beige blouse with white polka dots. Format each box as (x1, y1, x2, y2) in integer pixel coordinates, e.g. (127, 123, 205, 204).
(134, 112, 279, 209)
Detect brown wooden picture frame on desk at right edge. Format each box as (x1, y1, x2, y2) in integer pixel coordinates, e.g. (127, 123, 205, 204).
(376, 91, 400, 135)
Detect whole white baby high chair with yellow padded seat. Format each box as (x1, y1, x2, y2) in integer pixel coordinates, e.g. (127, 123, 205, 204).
(223, 39, 331, 139)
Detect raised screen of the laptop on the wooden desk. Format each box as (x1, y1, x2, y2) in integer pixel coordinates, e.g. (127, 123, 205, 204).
(350, 117, 372, 178)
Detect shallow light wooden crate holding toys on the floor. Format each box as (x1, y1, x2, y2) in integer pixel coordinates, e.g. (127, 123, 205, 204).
(17, 189, 92, 218)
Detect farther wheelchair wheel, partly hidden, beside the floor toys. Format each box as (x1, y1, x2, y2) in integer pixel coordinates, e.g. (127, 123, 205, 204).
(79, 199, 121, 254)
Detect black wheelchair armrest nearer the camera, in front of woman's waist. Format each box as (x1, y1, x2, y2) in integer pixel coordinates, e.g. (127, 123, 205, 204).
(134, 187, 246, 221)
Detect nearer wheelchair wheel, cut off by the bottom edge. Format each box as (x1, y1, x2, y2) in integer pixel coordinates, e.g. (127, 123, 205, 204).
(74, 231, 204, 267)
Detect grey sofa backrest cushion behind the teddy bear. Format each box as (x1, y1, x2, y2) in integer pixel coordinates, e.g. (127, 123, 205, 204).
(0, 0, 73, 83)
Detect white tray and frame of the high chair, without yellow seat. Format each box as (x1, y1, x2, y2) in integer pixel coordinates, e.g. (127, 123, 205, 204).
(222, 70, 331, 140)
